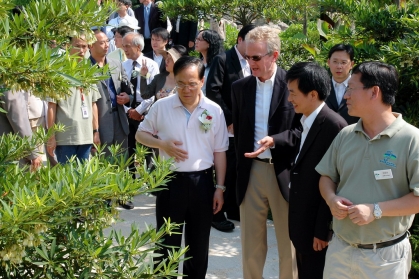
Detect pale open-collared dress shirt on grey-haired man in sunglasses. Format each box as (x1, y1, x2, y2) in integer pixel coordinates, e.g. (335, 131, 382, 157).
(254, 65, 277, 159)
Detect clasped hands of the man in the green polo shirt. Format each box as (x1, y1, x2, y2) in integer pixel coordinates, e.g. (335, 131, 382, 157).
(327, 195, 375, 226)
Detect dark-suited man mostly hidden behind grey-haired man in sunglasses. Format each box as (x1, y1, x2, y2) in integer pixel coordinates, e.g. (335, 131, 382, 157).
(206, 25, 256, 231)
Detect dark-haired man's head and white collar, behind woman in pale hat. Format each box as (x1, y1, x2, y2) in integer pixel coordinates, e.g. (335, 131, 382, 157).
(144, 27, 170, 73)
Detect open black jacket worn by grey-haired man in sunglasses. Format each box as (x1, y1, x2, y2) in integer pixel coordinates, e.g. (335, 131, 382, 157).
(231, 67, 298, 205)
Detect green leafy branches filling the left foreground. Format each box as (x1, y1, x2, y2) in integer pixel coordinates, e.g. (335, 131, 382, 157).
(0, 0, 187, 279)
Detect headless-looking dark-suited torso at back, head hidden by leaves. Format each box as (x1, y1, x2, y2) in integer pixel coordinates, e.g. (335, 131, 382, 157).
(170, 15, 198, 51)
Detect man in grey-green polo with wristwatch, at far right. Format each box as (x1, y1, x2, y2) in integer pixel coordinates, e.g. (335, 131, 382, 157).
(316, 62, 419, 279)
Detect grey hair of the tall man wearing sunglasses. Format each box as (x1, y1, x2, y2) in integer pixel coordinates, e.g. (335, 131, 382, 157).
(245, 26, 281, 53)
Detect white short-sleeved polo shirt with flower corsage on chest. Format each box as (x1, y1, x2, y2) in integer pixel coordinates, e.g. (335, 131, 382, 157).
(138, 92, 228, 172)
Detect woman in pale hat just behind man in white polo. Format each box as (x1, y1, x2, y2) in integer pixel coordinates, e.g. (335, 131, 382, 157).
(140, 45, 188, 101)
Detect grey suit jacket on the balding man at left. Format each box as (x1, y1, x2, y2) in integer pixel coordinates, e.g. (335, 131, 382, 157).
(96, 58, 132, 144)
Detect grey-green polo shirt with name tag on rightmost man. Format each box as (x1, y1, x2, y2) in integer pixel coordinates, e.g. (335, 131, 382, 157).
(316, 113, 419, 244)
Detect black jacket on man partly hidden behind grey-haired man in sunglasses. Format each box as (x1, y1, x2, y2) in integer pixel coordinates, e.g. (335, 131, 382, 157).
(206, 47, 243, 126)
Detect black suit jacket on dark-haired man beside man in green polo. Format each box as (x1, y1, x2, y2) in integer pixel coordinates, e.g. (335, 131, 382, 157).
(283, 105, 347, 254)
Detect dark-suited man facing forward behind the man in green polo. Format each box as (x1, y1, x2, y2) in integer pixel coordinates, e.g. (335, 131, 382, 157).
(326, 44, 359, 125)
